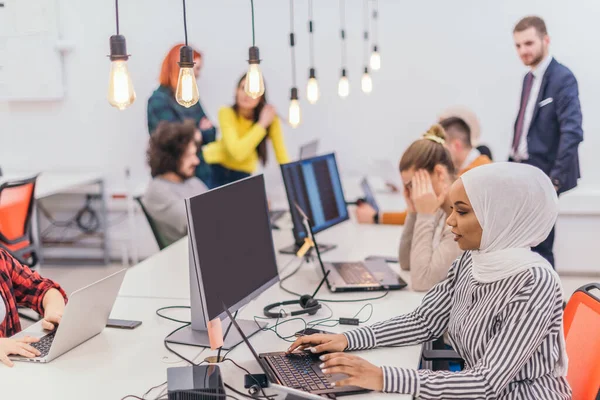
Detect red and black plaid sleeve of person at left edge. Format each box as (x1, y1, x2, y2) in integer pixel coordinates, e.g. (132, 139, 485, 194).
(0, 252, 67, 315)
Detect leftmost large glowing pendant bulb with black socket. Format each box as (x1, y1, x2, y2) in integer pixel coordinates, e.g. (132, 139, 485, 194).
(108, 35, 135, 110)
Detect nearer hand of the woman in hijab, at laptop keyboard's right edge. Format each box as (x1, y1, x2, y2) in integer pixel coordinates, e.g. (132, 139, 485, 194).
(319, 353, 383, 391)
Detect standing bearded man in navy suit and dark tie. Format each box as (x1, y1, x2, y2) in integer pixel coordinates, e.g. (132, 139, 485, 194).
(509, 16, 583, 266)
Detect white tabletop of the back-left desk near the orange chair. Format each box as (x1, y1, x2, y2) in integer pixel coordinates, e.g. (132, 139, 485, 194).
(0, 171, 103, 199)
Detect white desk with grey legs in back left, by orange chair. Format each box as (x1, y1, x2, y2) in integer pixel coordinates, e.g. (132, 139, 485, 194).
(0, 171, 110, 264)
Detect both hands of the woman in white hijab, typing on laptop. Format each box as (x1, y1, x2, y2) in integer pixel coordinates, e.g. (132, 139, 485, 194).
(287, 334, 383, 391)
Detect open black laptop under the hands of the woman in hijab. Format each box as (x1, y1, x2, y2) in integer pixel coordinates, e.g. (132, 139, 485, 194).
(224, 307, 369, 396)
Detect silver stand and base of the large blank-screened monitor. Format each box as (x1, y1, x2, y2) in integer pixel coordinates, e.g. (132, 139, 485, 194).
(165, 236, 268, 350)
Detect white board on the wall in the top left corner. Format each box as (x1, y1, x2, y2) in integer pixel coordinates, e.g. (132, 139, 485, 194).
(0, 0, 64, 101)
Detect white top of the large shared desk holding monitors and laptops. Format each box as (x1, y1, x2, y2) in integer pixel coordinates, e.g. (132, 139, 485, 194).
(5, 180, 423, 400)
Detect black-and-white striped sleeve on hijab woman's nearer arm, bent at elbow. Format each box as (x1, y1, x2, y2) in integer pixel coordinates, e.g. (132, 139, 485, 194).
(410, 268, 561, 400)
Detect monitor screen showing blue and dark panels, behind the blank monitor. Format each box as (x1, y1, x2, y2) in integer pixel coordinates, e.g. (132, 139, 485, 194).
(281, 153, 348, 242)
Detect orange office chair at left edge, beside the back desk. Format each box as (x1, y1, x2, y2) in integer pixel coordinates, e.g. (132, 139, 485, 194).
(0, 175, 38, 267)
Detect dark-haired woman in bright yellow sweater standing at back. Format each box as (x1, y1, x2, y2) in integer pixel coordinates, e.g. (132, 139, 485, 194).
(202, 75, 290, 187)
